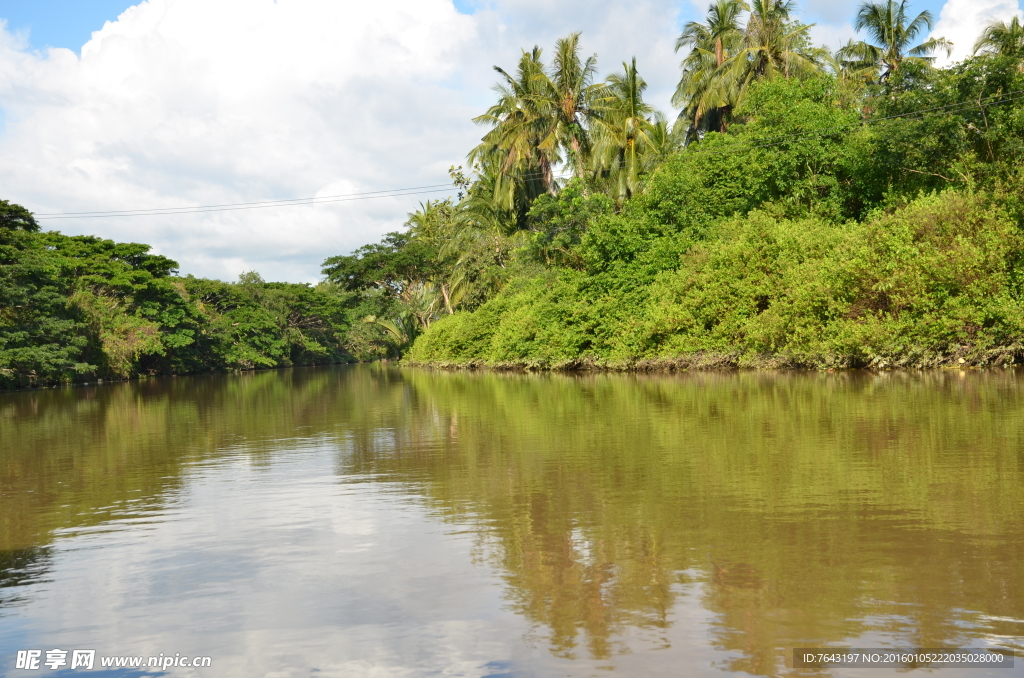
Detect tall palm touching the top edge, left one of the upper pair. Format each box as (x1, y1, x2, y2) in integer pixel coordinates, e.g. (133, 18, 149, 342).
(672, 0, 750, 132)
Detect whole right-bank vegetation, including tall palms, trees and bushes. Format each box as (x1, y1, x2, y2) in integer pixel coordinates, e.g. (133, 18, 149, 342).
(385, 0, 1024, 369)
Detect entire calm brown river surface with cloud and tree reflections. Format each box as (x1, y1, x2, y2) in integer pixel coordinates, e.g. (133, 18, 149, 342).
(0, 367, 1024, 678)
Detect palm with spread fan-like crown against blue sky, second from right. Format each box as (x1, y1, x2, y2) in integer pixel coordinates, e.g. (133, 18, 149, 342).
(839, 0, 953, 82)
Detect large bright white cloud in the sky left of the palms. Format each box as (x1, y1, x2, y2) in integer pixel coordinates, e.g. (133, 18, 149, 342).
(0, 0, 478, 280)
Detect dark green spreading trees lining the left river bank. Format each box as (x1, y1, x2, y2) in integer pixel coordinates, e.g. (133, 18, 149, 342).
(0, 225, 364, 388)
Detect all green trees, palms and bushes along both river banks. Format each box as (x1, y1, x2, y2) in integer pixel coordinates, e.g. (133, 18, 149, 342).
(6, 0, 1024, 388)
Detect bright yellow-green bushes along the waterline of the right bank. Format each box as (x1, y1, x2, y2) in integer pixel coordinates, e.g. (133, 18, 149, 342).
(409, 192, 1024, 368)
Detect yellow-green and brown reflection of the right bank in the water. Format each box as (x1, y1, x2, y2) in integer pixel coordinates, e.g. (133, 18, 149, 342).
(343, 371, 1024, 675)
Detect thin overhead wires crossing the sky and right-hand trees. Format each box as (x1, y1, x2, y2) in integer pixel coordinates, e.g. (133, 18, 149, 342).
(34, 89, 1024, 220)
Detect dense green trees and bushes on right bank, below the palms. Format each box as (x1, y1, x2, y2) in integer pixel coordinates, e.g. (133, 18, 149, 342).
(385, 47, 1024, 368)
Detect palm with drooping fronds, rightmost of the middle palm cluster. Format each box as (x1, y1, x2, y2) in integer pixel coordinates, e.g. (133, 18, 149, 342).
(594, 57, 664, 204)
